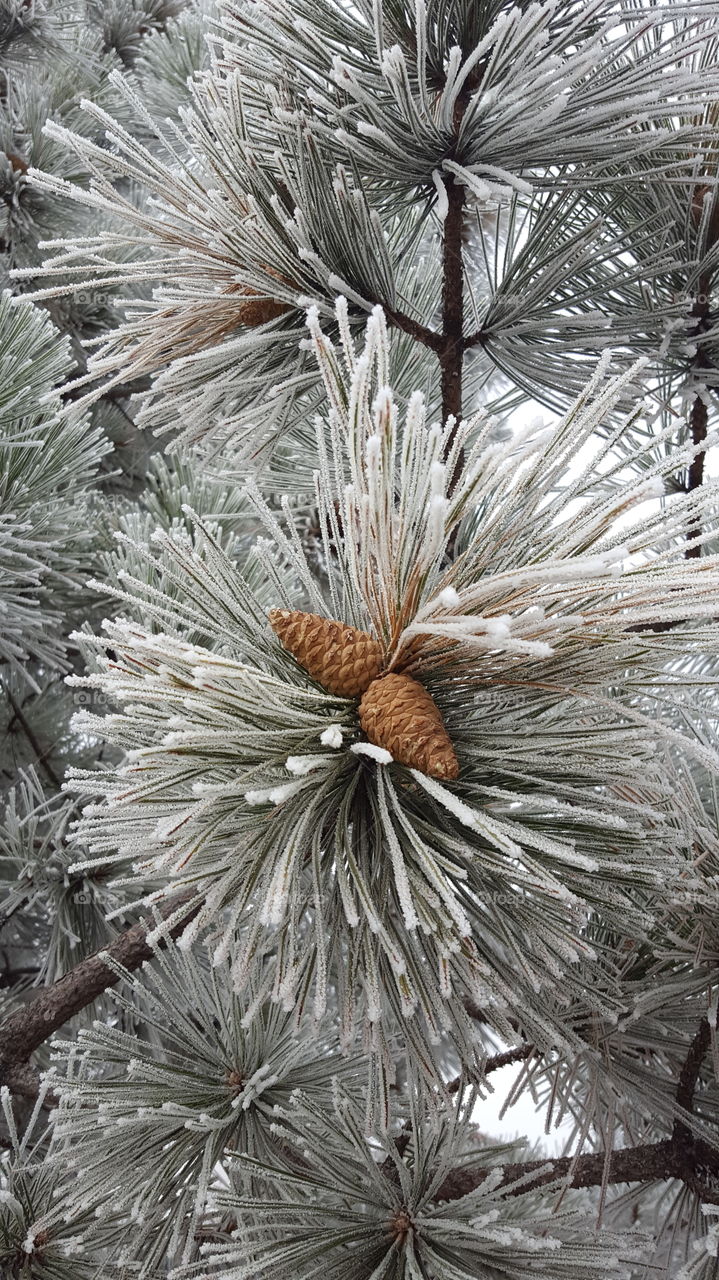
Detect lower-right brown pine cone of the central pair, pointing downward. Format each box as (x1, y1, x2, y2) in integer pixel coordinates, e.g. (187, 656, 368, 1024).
(360, 672, 459, 778)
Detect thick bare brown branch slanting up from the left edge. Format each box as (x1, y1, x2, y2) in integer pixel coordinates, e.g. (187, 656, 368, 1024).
(0, 890, 196, 1088)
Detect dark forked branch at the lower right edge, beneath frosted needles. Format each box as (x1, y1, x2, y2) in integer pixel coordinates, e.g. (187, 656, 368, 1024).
(436, 1019, 719, 1204)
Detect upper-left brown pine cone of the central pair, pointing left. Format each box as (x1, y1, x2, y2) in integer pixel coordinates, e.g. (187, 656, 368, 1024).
(270, 609, 384, 698)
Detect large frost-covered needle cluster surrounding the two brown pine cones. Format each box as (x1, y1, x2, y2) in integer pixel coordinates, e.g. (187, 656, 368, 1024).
(65, 302, 719, 1075)
